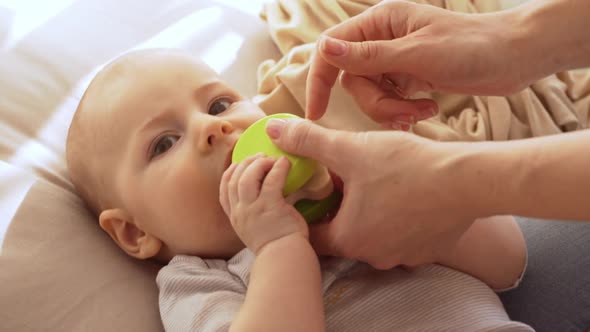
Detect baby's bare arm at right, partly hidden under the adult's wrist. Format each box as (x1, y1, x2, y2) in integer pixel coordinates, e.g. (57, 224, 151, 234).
(439, 216, 526, 290)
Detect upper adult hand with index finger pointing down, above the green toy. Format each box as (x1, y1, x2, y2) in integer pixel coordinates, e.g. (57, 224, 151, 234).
(306, 1, 540, 124)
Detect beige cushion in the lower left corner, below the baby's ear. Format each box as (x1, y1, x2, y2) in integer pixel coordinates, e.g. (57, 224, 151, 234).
(0, 165, 162, 331)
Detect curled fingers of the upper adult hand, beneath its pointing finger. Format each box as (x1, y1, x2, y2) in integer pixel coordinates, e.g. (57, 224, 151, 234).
(340, 73, 438, 124)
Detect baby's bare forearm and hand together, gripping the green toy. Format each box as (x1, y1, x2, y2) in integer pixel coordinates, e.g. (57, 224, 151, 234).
(220, 156, 325, 331)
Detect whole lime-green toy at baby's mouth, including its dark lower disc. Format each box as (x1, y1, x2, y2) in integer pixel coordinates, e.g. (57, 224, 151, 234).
(232, 113, 342, 223)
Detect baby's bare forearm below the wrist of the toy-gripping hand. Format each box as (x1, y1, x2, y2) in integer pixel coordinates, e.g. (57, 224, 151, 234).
(231, 234, 324, 331)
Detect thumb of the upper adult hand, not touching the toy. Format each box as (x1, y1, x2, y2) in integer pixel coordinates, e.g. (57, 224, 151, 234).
(318, 35, 411, 75)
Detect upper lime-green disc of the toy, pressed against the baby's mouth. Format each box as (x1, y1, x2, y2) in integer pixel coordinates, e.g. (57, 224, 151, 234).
(232, 113, 316, 196)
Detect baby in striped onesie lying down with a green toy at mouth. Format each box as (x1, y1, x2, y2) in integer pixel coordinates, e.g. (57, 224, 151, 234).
(67, 50, 532, 331)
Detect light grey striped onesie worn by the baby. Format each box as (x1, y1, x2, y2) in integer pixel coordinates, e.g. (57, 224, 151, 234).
(156, 249, 534, 332)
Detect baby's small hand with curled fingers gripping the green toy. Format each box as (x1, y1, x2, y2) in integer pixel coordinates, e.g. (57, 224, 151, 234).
(219, 154, 309, 254)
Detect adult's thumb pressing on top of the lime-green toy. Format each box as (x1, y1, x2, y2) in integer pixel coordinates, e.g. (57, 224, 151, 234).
(266, 119, 349, 174)
